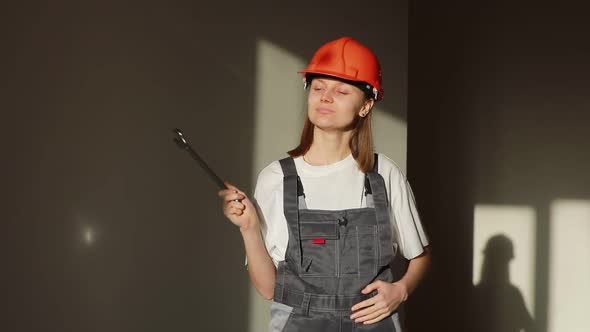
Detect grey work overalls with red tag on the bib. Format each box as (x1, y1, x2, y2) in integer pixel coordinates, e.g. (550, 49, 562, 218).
(270, 155, 401, 332)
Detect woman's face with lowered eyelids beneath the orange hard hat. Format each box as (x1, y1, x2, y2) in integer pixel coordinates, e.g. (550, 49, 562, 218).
(307, 77, 373, 131)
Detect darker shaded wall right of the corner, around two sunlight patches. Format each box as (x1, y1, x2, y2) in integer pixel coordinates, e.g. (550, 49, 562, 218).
(408, 1, 590, 332)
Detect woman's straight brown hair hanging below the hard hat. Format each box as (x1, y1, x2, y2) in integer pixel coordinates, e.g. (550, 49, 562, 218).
(287, 111, 375, 173)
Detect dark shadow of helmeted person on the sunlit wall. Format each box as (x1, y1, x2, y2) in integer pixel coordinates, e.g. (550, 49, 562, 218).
(473, 234, 535, 332)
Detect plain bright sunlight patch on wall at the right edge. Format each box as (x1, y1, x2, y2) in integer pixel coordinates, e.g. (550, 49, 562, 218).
(548, 200, 590, 332)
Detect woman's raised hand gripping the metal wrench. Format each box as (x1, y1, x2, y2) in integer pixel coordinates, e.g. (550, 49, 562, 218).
(217, 182, 259, 232)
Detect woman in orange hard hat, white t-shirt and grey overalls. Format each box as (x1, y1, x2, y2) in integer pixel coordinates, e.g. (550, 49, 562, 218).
(219, 37, 430, 332)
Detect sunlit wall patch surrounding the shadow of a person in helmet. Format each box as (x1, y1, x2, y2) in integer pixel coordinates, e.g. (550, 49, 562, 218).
(473, 205, 536, 317)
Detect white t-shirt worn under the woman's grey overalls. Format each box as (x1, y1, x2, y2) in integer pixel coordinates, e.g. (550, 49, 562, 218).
(254, 154, 428, 265)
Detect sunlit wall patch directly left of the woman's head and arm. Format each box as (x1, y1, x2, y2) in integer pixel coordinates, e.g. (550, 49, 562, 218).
(249, 40, 305, 332)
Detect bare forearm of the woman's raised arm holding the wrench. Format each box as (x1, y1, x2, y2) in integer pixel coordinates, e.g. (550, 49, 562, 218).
(241, 227, 276, 300)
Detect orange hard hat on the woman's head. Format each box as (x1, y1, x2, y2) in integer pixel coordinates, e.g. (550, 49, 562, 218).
(299, 37, 383, 101)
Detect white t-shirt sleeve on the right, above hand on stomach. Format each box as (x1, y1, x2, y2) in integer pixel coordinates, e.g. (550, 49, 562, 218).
(379, 154, 429, 259)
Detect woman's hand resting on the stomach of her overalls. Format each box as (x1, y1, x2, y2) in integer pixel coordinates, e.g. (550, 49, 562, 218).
(350, 280, 408, 324)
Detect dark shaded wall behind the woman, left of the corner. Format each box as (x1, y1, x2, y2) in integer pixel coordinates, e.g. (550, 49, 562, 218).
(0, 1, 407, 332)
